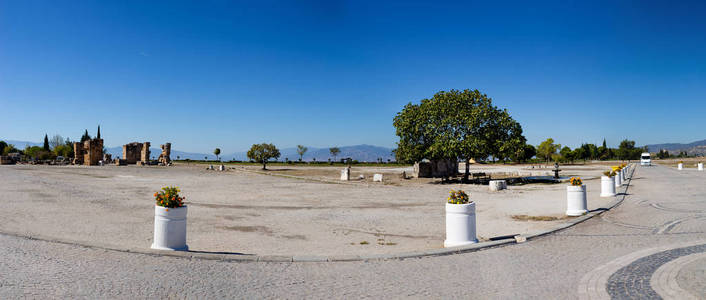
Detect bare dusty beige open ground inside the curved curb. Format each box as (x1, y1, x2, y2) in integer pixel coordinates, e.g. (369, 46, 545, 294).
(0, 165, 613, 256)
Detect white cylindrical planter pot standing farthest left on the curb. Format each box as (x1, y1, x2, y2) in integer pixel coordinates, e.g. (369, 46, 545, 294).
(152, 205, 189, 251)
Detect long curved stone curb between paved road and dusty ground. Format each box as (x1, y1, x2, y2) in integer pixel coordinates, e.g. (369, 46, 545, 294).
(0, 164, 635, 263)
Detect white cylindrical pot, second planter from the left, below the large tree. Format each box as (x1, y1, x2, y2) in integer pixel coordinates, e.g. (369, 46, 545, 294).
(444, 203, 478, 247)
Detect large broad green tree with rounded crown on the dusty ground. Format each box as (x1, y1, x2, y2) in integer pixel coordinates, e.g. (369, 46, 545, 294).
(393, 90, 525, 180)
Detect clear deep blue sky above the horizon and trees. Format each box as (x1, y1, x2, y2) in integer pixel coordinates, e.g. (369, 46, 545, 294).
(0, 0, 706, 153)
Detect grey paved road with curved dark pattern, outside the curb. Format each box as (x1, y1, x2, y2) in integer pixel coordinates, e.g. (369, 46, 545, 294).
(0, 167, 706, 299)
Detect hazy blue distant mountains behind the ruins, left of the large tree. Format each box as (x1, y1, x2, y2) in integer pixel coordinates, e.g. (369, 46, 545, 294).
(5, 140, 395, 162)
